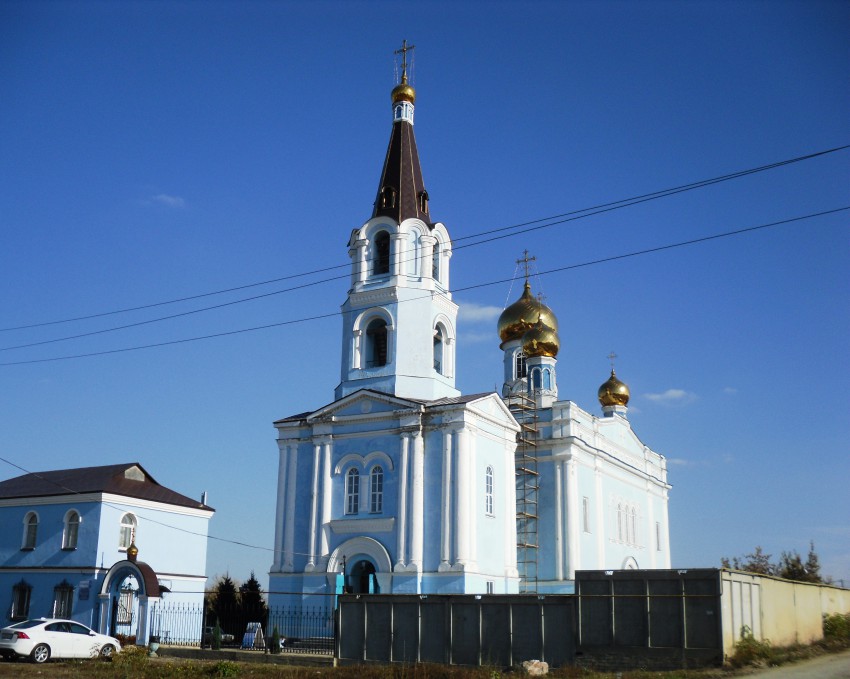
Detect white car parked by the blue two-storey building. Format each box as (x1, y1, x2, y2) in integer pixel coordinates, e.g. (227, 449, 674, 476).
(0, 618, 121, 663)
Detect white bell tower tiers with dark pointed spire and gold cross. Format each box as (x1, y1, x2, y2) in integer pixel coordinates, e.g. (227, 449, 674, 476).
(335, 41, 460, 401)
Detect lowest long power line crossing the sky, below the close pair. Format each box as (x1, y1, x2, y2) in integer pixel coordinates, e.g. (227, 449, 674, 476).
(0, 205, 850, 367)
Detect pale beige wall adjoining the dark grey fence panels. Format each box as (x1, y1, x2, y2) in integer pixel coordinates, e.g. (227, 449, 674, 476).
(720, 570, 850, 655)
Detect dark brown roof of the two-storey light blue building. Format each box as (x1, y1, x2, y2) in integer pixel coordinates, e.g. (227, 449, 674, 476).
(0, 462, 212, 510)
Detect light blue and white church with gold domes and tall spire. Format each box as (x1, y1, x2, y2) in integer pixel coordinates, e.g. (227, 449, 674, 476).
(269, 45, 670, 605)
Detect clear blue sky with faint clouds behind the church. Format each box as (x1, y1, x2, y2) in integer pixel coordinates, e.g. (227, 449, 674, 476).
(0, 0, 850, 584)
